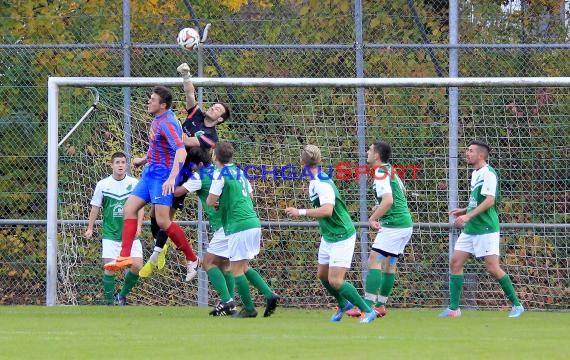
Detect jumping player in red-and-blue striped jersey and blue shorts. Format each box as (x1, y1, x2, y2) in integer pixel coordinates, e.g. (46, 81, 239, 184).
(105, 86, 198, 271)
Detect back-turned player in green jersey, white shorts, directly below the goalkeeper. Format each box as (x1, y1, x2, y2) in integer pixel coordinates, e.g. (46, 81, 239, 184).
(206, 142, 279, 318)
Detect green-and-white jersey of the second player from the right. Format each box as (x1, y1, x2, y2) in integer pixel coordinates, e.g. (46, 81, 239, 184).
(372, 164, 412, 228)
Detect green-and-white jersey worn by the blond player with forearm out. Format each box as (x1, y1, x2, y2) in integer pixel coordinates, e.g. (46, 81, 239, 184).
(309, 176, 356, 243)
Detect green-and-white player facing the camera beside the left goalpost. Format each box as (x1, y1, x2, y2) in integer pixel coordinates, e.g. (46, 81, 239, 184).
(85, 152, 144, 305)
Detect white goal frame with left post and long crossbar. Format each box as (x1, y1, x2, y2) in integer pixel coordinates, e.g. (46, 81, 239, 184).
(46, 77, 570, 306)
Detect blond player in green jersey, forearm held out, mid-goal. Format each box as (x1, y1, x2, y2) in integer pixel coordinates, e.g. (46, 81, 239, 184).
(285, 145, 376, 324)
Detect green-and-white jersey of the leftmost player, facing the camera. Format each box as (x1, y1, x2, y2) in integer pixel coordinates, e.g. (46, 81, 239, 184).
(91, 175, 138, 242)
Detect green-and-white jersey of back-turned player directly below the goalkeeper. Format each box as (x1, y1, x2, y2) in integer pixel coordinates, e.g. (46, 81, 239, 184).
(210, 164, 261, 235)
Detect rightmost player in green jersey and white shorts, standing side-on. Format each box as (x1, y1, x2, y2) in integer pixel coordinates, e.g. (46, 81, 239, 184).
(439, 141, 524, 317)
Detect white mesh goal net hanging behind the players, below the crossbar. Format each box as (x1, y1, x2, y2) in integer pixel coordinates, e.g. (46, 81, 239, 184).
(48, 79, 570, 309)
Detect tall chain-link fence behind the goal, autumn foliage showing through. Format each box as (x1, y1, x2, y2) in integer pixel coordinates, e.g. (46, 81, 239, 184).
(0, 1, 570, 309)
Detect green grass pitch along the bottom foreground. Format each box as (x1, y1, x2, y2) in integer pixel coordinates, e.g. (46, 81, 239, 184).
(0, 306, 570, 360)
